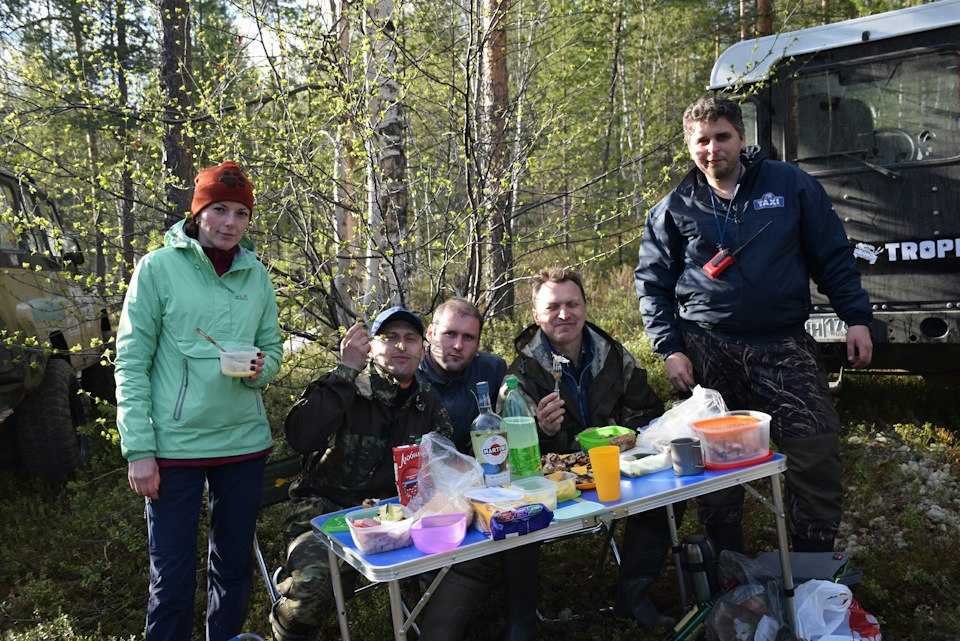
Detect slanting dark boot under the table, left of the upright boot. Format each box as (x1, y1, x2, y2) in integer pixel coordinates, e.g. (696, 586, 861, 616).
(420, 559, 493, 641)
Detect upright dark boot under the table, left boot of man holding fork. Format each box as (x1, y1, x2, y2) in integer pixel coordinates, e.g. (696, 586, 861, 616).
(500, 543, 540, 641)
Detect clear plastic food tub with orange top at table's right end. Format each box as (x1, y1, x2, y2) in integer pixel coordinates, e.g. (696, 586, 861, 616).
(690, 410, 773, 470)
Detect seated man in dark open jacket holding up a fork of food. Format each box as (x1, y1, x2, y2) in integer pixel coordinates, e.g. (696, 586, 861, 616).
(503, 267, 683, 641)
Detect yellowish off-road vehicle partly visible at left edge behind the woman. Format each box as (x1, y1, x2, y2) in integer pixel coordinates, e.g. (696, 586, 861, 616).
(0, 169, 114, 481)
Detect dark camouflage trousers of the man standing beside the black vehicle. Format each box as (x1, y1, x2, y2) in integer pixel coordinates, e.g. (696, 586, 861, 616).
(682, 331, 843, 541)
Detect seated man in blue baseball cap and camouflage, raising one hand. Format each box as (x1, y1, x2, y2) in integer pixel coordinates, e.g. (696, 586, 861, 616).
(270, 307, 453, 641)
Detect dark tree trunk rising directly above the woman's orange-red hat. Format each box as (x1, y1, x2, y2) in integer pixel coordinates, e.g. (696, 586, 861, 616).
(157, 0, 194, 227)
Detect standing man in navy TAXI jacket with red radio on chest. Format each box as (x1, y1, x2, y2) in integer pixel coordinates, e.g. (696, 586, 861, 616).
(635, 96, 873, 552)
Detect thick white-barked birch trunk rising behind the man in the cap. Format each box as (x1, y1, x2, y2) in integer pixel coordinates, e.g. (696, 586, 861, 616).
(364, 0, 409, 308)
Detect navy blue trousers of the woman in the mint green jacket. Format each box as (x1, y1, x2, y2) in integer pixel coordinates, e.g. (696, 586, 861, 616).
(146, 456, 267, 641)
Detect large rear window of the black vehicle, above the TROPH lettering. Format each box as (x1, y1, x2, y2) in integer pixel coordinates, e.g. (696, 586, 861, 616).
(790, 52, 960, 173)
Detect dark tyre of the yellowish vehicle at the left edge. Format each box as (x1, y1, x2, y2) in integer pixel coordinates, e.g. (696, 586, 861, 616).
(14, 358, 91, 482)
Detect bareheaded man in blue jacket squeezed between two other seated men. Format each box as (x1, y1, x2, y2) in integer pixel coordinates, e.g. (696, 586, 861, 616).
(417, 298, 507, 453)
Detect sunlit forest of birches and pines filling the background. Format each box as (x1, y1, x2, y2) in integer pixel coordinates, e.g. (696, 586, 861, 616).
(0, 0, 905, 350)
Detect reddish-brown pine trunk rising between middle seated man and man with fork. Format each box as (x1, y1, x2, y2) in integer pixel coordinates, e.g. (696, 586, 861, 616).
(480, 0, 514, 318)
